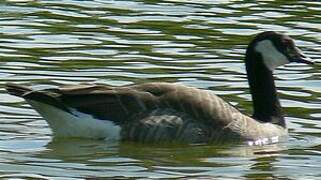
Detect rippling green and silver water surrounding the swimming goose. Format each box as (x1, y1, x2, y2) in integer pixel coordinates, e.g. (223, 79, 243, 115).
(0, 0, 321, 179)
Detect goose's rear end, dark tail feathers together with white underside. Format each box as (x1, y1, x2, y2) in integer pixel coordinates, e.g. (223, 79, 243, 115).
(5, 83, 120, 140)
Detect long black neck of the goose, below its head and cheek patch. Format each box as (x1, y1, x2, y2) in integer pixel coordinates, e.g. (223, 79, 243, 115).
(245, 42, 285, 126)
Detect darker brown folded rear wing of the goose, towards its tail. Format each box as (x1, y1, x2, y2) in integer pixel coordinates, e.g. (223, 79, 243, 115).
(53, 86, 158, 124)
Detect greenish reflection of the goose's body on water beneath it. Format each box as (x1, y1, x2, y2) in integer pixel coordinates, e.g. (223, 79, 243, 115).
(37, 140, 286, 178)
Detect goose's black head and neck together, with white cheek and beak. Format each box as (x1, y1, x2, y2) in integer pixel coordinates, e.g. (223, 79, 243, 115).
(245, 31, 313, 127)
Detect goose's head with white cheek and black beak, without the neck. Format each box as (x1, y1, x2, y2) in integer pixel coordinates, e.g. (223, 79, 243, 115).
(247, 31, 313, 71)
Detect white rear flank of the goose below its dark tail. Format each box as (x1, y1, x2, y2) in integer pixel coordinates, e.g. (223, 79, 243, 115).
(28, 100, 121, 140)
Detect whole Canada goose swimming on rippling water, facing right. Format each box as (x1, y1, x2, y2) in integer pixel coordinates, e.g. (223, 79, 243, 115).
(6, 31, 313, 144)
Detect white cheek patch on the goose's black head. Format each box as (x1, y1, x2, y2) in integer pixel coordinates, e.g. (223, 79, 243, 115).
(255, 40, 290, 71)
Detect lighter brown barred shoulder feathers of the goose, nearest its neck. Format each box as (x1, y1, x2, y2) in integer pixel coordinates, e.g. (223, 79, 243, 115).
(153, 85, 241, 127)
